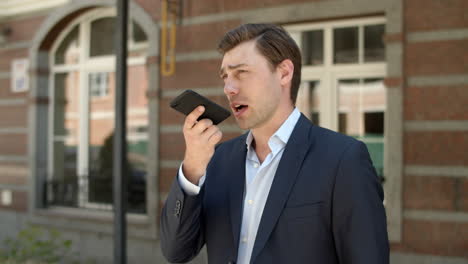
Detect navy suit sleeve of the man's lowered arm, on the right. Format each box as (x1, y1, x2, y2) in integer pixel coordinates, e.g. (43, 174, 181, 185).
(332, 141, 389, 264)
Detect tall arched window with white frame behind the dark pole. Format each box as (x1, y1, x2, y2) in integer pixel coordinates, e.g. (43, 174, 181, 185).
(46, 9, 148, 213)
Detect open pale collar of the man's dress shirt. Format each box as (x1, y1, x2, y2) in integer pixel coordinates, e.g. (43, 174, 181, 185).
(245, 107, 301, 154)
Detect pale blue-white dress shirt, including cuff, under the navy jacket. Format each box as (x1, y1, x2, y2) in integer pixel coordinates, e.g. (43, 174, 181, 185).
(178, 108, 300, 264)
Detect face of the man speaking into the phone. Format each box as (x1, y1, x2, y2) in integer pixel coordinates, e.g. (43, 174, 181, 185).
(220, 41, 284, 129)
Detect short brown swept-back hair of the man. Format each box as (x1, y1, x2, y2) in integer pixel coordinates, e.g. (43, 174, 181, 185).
(218, 24, 302, 104)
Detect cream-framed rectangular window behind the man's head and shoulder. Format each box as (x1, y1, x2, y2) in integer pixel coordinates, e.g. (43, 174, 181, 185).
(286, 18, 386, 182)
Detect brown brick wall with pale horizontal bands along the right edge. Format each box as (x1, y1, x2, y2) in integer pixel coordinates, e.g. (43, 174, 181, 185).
(392, 0, 468, 258)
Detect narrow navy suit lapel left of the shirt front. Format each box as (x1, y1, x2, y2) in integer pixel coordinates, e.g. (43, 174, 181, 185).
(226, 136, 247, 255)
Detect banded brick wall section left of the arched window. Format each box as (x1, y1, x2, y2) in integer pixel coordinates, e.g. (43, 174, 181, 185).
(0, 12, 44, 212)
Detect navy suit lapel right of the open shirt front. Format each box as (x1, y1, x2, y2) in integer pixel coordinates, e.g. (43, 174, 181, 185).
(250, 114, 311, 263)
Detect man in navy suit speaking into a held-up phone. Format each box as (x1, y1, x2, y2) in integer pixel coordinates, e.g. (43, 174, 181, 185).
(161, 24, 389, 264)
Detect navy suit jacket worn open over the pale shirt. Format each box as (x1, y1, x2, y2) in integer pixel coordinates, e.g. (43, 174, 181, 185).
(161, 115, 389, 264)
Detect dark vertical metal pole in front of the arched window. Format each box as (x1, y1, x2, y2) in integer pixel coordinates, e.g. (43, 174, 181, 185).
(113, 0, 128, 264)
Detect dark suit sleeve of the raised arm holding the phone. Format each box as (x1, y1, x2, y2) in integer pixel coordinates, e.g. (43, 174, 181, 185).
(160, 173, 205, 263)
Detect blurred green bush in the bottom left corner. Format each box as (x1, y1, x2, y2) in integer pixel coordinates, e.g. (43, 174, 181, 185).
(0, 226, 92, 264)
